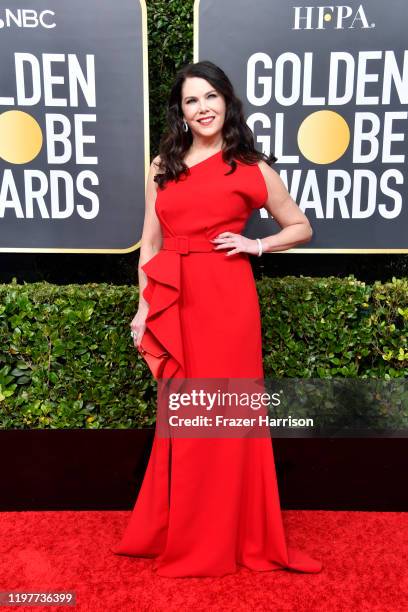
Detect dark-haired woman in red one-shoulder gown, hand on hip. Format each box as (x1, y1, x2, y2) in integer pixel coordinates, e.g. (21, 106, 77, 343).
(113, 62, 322, 577)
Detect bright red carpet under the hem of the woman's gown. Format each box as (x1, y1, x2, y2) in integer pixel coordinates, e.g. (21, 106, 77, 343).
(0, 510, 408, 612)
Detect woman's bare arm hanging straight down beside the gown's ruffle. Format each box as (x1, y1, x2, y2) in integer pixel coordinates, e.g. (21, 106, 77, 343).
(130, 156, 163, 347)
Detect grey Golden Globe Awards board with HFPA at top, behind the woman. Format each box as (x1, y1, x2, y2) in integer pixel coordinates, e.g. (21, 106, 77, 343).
(194, 0, 408, 253)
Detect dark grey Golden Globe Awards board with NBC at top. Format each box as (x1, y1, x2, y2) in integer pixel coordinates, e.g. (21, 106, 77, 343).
(0, 0, 148, 253)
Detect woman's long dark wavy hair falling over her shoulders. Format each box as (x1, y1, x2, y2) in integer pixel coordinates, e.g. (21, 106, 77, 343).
(154, 61, 277, 188)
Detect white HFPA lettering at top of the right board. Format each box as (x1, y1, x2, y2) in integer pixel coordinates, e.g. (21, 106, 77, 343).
(292, 4, 375, 30)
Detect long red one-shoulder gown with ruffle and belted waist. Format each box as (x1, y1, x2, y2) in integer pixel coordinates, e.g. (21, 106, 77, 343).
(112, 151, 322, 577)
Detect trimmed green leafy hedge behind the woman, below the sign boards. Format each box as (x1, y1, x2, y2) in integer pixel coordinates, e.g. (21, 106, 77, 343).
(0, 276, 408, 429)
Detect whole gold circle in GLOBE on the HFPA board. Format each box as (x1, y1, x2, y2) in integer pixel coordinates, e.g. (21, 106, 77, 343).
(297, 110, 350, 164)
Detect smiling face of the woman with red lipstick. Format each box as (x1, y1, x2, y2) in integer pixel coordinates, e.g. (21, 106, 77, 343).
(181, 77, 226, 139)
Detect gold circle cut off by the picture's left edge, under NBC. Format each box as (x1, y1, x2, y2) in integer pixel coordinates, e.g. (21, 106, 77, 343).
(0, 111, 43, 164)
